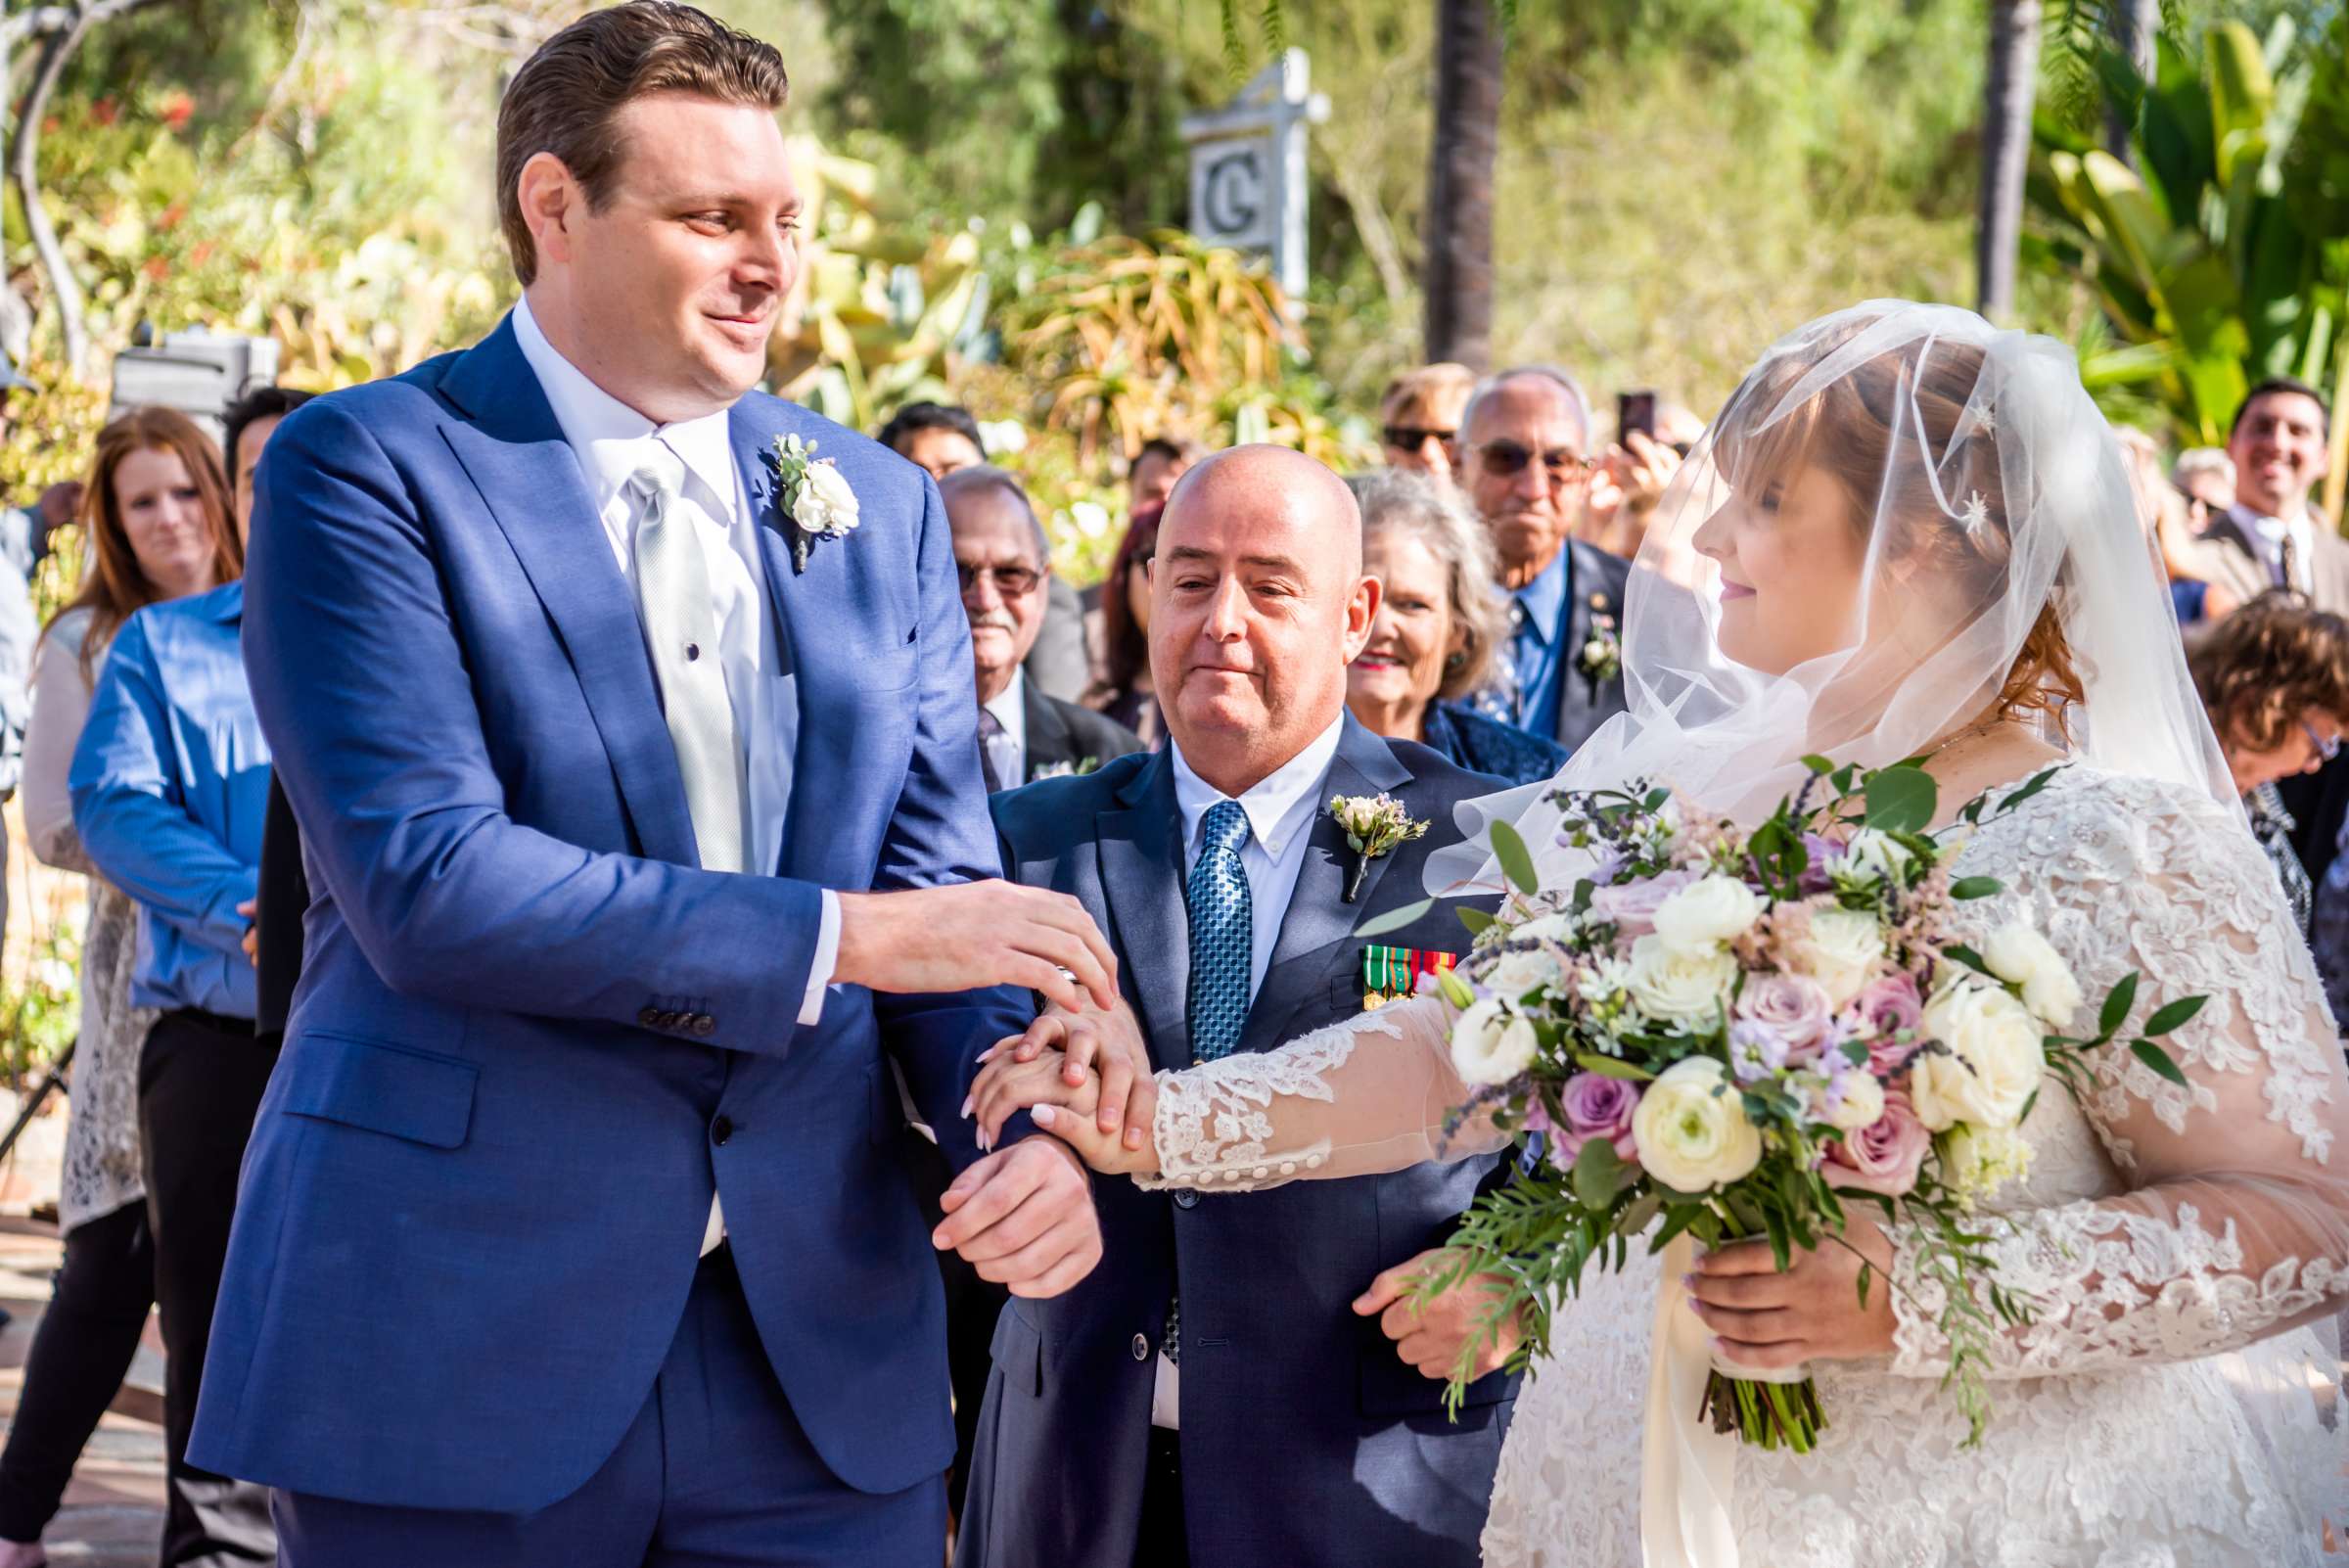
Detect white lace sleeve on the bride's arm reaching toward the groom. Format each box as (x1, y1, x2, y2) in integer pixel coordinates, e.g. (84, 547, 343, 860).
(1141, 992, 1508, 1192)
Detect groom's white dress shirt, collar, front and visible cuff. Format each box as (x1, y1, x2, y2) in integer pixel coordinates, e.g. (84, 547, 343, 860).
(515, 299, 841, 1024)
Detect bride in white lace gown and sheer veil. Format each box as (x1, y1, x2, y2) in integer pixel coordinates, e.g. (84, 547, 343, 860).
(975, 302, 2349, 1568)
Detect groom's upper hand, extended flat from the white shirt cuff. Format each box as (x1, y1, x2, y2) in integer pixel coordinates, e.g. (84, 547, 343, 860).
(832, 883, 1118, 1012)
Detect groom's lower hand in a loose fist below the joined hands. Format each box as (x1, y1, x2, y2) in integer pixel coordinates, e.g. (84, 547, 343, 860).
(930, 1136, 1102, 1296)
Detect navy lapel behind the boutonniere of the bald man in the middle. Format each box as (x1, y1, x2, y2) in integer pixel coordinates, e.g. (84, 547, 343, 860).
(1240, 714, 1411, 1051)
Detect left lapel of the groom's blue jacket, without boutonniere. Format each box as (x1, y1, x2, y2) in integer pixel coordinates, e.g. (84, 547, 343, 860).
(441, 322, 700, 866)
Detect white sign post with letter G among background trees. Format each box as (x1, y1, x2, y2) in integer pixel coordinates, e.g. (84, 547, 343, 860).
(1181, 49, 1329, 299)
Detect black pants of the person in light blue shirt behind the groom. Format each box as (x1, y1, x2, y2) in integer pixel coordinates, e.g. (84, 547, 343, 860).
(139, 1009, 277, 1568)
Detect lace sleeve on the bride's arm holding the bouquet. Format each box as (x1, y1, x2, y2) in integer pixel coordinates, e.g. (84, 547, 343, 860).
(1893, 779, 2349, 1378)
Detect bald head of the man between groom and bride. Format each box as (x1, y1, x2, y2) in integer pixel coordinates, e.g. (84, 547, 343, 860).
(1151, 446, 1379, 796)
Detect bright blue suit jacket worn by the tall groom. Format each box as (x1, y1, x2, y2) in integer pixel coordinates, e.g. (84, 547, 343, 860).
(193, 324, 1029, 1511)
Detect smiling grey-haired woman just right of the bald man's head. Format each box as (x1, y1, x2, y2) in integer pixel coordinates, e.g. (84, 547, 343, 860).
(1346, 467, 1567, 784)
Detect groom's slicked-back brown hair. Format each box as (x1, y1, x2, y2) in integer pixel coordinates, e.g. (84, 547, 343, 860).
(498, 0, 792, 284)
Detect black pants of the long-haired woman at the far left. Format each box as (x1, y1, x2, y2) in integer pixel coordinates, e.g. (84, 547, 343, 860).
(0, 1204, 155, 1543)
